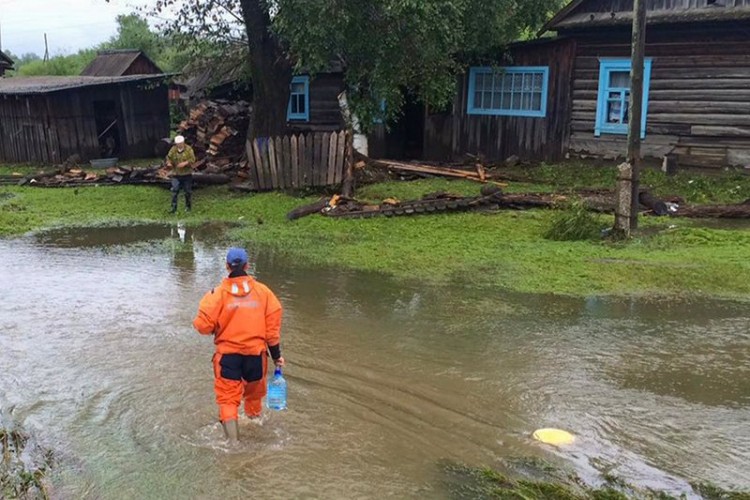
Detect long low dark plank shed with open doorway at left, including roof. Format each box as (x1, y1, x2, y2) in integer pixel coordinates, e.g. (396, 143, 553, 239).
(0, 75, 169, 164)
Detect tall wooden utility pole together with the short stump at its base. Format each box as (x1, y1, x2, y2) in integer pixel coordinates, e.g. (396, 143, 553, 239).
(614, 0, 646, 238)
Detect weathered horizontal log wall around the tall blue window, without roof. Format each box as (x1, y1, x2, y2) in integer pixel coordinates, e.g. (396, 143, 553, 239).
(570, 26, 750, 167)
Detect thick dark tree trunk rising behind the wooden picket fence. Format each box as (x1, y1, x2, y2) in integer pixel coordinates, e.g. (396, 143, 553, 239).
(240, 0, 292, 139)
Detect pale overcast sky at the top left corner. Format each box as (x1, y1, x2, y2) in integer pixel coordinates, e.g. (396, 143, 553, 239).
(0, 0, 145, 56)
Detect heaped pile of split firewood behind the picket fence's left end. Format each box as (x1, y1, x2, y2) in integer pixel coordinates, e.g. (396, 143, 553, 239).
(178, 100, 250, 164)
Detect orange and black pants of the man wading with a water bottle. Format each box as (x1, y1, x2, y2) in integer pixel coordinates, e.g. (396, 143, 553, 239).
(213, 353, 268, 422)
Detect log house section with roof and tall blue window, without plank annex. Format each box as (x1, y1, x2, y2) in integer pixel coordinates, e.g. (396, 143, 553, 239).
(544, 0, 750, 167)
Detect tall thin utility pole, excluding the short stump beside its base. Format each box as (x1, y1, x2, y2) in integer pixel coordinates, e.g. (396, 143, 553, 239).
(627, 0, 646, 230)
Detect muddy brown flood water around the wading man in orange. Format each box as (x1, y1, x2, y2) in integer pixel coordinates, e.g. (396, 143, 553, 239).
(0, 226, 750, 498)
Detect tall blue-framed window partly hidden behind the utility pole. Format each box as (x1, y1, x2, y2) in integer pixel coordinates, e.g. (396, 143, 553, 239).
(594, 58, 652, 138)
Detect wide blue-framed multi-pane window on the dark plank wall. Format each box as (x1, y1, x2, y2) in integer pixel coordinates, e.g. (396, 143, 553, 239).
(467, 66, 549, 118)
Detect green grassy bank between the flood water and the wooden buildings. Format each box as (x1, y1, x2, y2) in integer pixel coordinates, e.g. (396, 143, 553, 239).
(0, 162, 750, 298)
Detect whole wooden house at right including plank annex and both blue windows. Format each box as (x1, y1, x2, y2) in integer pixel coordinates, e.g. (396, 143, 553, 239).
(424, 0, 750, 168)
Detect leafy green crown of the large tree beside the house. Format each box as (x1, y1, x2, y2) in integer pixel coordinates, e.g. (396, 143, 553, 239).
(273, 0, 560, 128)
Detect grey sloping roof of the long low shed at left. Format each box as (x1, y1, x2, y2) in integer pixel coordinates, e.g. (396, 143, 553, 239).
(0, 73, 169, 95)
